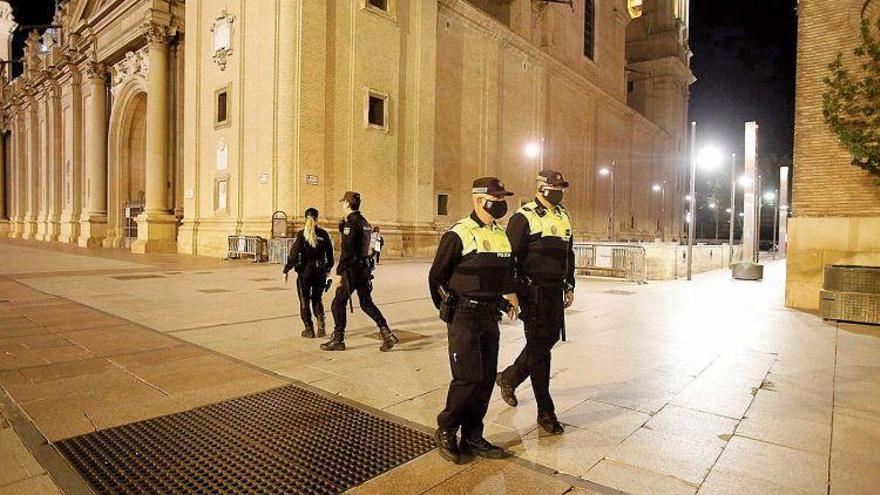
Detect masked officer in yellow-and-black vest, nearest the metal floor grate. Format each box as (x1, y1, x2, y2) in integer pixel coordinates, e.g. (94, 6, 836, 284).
(428, 177, 517, 463)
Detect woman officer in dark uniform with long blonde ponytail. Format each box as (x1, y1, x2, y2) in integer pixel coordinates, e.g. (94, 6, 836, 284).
(284, 208, 333, 339)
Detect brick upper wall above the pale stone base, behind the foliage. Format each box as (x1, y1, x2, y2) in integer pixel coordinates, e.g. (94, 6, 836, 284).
(792, 0, 880, 217)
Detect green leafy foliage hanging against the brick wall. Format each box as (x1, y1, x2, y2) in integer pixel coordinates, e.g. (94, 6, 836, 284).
(822, 19, 880, 184)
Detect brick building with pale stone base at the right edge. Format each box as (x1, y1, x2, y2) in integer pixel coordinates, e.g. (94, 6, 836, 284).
(785, 0, 880, 310)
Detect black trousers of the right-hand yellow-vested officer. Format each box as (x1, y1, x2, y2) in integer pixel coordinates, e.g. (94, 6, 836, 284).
(502, 287, 565, 412)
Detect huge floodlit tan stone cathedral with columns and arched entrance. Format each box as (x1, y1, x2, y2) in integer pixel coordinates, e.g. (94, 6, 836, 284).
(0, 0, 693, 256)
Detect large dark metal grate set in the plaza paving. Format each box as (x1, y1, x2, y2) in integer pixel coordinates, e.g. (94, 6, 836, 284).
(57, 386, 433, 494)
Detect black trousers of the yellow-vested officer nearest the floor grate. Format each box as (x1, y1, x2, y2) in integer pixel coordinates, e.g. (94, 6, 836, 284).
(437, 308, 499, 439)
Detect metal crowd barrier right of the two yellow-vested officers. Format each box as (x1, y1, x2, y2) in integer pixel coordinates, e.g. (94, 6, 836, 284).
(574, 242, 648, 284)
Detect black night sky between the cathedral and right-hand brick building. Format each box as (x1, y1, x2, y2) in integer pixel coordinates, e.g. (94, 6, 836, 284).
(690, 0, 797, 164)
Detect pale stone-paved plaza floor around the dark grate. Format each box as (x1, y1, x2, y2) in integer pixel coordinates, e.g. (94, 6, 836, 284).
(0, 241, 880, 495)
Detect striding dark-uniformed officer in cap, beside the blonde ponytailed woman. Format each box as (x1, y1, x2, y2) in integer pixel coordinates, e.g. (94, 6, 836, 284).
(321, 191, 398, 352)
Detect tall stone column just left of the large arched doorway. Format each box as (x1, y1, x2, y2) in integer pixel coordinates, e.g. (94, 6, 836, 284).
(78, 62, 107, 247)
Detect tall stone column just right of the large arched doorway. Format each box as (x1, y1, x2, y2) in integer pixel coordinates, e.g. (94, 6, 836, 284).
(131, 22, 177, 253)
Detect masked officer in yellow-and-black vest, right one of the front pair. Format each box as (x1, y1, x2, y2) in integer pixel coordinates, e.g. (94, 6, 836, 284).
(496, 170, 574, 435)
